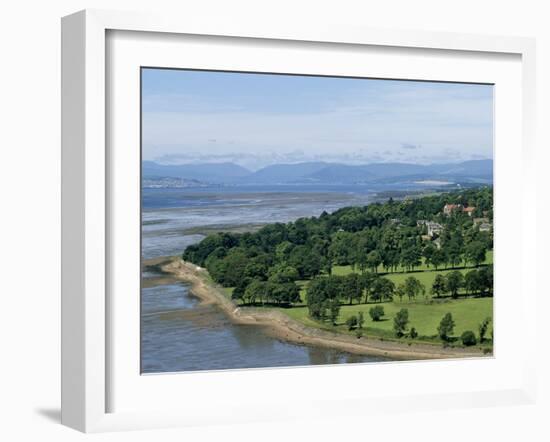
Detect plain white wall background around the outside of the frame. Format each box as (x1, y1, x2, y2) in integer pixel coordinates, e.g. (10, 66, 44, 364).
(0, 0, 550, 442)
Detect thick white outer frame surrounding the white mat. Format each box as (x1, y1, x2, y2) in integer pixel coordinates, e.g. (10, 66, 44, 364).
(62, 10, 536, 432)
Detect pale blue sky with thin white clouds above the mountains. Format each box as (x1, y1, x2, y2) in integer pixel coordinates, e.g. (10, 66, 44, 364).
(142, 68, 493, 170)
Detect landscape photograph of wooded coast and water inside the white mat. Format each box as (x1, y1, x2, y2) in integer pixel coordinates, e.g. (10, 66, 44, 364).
(141, 67, 500, 374)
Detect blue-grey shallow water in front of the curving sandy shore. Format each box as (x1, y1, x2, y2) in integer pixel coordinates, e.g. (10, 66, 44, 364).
(142, 276, 386, 373)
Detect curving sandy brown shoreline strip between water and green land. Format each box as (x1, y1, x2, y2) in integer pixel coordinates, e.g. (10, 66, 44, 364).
(144, 257, 486, 360)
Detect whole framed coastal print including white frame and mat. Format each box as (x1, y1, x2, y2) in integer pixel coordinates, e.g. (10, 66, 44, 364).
(62, 11, 536, 431)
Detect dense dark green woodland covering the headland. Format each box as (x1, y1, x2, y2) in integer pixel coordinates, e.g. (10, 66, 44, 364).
(183, 187, 493, 332)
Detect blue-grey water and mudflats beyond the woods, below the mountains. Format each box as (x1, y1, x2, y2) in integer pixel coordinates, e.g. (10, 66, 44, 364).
(142, 186, 380, 259)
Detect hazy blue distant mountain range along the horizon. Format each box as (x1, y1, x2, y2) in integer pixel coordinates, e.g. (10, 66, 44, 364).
(142, 160, 493, 185)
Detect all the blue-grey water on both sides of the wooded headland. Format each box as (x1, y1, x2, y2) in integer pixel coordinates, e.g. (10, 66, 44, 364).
(141, 186, 392, 373)
